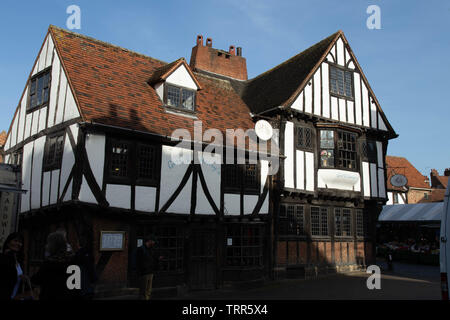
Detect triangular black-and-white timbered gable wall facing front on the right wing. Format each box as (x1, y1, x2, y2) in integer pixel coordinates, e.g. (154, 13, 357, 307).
(285, 31, 395, 137)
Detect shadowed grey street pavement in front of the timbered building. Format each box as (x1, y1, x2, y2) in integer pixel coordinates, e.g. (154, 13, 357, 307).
(98, 260, 441, 300)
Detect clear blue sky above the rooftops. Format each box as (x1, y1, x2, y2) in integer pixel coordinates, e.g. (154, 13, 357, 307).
(0, 0, 450, 175)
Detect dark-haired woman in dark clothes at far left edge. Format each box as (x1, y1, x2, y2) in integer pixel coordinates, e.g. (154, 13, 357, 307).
(0, 233, 25, 300)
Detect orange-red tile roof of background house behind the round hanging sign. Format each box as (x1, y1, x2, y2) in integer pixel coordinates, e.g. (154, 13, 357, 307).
(386, 156, 431, 190)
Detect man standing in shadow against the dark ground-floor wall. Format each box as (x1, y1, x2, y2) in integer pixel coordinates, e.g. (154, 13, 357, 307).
(136, 236, 160, 300)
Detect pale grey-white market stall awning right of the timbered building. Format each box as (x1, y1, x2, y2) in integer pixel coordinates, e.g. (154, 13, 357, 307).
(378, 202, 444, 221)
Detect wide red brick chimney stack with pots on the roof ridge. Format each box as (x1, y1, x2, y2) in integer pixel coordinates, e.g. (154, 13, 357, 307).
(190, 35, 248, 80)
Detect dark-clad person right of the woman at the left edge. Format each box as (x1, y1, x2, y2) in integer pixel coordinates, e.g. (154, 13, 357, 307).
(31, 232, 80, 300)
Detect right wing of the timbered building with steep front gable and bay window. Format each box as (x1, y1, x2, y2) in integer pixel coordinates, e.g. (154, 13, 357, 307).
(235, 31, 397, 277)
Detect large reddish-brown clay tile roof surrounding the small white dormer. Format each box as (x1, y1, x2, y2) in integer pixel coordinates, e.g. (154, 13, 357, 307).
(50, 26, 254, 145)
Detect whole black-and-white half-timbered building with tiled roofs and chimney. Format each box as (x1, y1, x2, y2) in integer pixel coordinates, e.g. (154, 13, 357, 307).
(4, 26, 396, 289)
